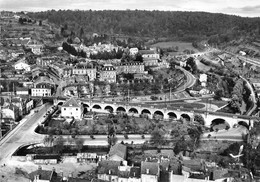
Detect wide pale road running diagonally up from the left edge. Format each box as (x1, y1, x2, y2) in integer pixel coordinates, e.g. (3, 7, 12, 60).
(0, 104, 51, 165)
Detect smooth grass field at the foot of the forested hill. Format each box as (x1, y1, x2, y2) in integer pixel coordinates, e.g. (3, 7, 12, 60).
(151, 41, 198, 53)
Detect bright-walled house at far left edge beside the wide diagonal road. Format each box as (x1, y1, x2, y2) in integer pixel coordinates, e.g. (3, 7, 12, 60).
(2, 104, 20, 121)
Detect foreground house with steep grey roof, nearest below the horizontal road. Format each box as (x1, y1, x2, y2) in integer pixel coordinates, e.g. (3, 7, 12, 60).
(108, 143, 127, 161)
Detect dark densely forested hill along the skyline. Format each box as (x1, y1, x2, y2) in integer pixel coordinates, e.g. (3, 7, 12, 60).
(26, 10, 260, 39)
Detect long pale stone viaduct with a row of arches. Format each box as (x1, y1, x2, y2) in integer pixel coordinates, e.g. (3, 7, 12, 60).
(54, 98, 253, 127)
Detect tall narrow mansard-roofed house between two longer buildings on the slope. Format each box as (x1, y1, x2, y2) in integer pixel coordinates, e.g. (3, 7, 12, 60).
(99, 64, 116, 83)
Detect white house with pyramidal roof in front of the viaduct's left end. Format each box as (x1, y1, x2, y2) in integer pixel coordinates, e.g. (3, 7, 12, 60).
(61, 97, 83, 119)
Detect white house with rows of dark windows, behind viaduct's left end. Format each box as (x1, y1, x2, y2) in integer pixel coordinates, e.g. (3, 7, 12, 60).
(31, 83, 53, 97)
